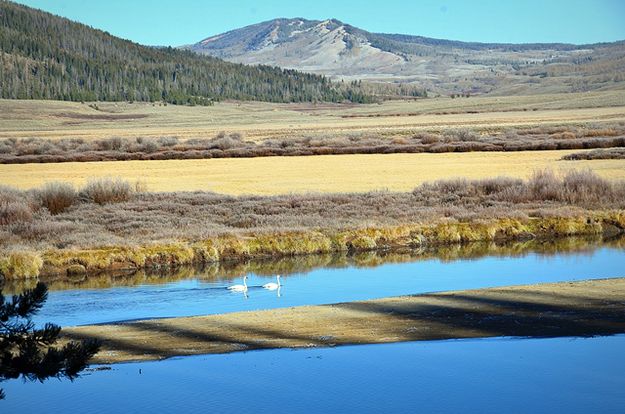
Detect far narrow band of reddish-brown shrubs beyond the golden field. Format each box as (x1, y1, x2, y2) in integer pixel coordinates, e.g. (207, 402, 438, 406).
(0, 124, 625, 163)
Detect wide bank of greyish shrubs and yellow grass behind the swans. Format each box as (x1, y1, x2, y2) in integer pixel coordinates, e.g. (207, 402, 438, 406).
(0, 171, 625, 279)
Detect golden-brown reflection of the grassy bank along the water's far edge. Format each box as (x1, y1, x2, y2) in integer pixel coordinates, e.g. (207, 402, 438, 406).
(3, 236, 625, 294)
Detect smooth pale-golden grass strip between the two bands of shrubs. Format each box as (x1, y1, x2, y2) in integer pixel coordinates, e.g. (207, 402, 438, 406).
(0, 150, 625, 195)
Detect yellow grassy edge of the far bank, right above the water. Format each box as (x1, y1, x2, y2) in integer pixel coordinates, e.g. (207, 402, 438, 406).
(0, 211, 625, 279)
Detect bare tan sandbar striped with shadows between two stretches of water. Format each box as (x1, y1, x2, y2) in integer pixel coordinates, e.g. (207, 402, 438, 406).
(63, 278, 625, 363)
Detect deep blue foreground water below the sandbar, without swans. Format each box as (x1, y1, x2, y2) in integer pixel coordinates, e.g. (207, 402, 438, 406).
(0, 335, 625, 414)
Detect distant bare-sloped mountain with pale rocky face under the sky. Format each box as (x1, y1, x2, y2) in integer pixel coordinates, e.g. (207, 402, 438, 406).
(188, 18, 625, 94)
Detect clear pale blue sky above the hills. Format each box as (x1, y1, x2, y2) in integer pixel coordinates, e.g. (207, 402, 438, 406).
(12, 0, 625, 46)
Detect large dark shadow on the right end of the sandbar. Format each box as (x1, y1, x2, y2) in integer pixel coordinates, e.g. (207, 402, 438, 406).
(339, 291, 625, 340)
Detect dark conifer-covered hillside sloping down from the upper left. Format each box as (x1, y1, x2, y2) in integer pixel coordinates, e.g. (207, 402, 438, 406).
(0, 0, 370, 104)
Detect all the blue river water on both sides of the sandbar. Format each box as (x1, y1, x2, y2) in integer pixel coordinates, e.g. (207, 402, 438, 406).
(0, 236, 625, 414)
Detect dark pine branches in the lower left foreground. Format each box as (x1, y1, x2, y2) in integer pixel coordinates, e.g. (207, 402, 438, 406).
(0, 283, 100, 399)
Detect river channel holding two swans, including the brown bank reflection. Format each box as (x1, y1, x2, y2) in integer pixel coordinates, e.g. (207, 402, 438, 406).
(3, 234, 625, 326)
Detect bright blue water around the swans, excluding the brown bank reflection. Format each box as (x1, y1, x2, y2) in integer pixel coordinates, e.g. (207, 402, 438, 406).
(30, 241, 625, 326)
